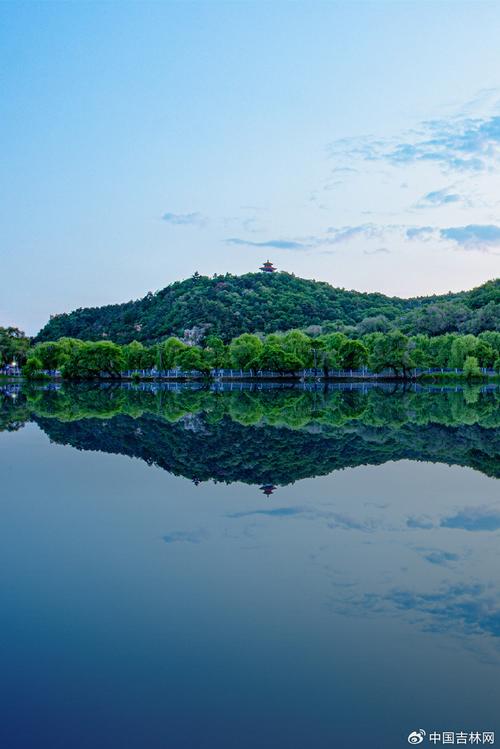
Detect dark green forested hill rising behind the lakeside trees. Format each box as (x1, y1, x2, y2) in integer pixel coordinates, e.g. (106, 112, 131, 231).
(36, 272, 500, 343)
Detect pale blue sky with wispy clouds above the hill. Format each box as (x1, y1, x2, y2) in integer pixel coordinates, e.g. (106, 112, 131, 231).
(0, 0, 500, 334)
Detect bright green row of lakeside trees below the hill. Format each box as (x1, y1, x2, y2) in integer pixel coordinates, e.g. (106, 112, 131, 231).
(23, 330, 500, 379)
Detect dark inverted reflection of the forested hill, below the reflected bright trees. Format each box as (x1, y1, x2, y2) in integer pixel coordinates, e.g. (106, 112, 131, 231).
(35, 414, 500, 486)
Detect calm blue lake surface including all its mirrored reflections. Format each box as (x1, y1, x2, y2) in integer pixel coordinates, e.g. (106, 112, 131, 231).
(0, 385, 500, 749)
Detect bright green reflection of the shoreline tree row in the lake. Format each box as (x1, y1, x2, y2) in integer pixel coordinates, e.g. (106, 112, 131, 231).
(5, 384, 500, 429)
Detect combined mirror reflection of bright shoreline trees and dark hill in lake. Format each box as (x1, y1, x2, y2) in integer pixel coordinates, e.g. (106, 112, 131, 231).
(3, 387, 500, 484)
